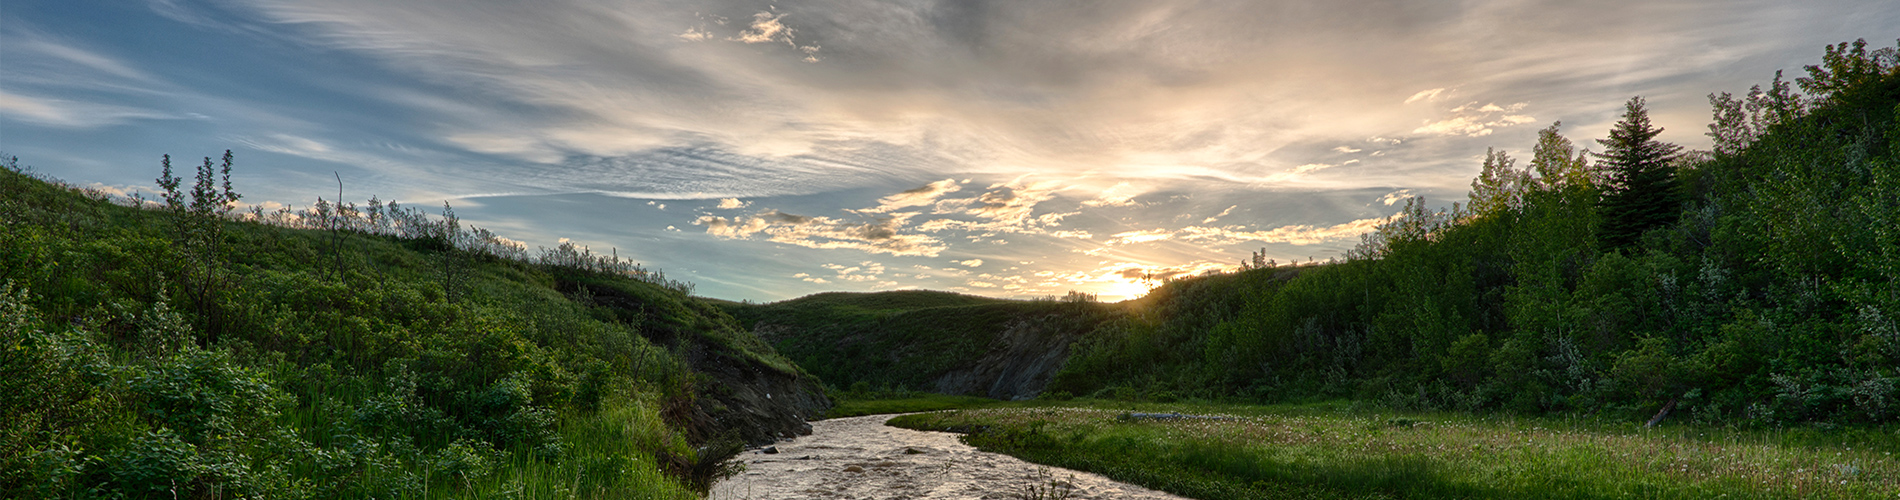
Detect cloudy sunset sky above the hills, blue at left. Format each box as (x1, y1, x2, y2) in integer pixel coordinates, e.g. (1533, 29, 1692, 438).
(0, 0, 1900, 302)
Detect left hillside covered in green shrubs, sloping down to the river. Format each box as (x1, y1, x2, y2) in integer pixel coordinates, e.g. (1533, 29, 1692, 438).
(0, 152, 830, 498)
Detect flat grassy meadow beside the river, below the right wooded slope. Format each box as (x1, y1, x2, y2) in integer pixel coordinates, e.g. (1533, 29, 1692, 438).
(891, 401, 1900, 498)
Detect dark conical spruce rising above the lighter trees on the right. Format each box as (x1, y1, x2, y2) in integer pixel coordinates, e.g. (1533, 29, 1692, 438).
(1596, 97, 1682, 247)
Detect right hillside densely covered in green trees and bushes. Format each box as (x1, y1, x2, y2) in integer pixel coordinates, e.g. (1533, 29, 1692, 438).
(1049, 42, 1900, 426)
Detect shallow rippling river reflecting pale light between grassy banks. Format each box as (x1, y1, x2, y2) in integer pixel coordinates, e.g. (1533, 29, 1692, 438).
(713, 414, 1182, 500)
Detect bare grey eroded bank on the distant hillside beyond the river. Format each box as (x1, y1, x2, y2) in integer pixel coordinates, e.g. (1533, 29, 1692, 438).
(933, 319, 1075, 399)
